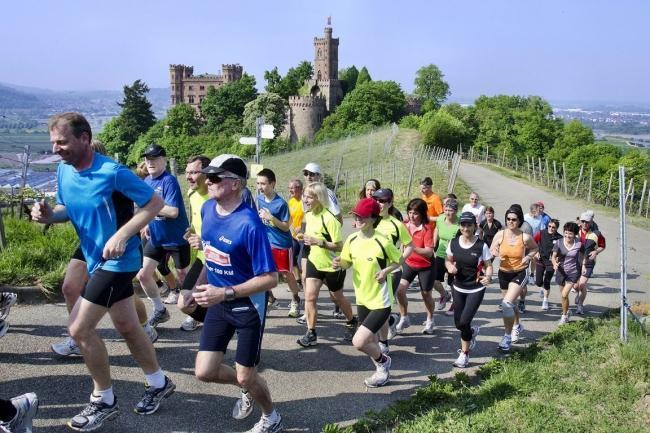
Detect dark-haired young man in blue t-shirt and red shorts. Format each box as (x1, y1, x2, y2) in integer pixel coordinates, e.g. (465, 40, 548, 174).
(257, 168, 300, 317)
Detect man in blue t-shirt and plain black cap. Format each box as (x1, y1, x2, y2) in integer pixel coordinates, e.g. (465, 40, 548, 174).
(138, 144, 191, 328)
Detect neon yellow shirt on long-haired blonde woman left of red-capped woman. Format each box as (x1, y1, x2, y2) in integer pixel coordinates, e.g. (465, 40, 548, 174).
(305, 209, 343, 272)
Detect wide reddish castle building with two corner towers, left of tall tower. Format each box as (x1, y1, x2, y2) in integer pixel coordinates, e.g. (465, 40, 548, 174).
(169, 65, 243, 106)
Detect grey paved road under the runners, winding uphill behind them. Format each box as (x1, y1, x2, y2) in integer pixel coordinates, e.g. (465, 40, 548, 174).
(0, 165, 650, 433)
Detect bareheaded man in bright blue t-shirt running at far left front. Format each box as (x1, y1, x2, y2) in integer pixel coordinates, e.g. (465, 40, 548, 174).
(32, 113, 176, 431)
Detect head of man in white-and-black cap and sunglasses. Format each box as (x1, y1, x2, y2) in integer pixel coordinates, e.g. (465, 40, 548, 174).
(201, 153, 248, 201)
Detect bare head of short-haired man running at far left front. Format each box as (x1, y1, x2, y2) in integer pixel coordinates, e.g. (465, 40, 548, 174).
(47, 113, 93, 167)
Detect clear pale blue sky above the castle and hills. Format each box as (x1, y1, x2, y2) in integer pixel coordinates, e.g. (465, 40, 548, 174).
(0, 0, 650, 103)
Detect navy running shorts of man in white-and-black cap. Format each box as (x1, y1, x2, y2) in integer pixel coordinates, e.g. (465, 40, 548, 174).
(199, 298, 268, 367)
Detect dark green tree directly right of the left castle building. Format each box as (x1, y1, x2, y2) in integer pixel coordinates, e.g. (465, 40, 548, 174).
(201, 74, 257, 135)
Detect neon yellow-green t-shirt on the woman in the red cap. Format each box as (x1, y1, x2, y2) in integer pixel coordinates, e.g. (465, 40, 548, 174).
(341, 231, 402, 310)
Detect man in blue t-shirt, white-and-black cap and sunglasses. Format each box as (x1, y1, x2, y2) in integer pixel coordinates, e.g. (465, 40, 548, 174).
(193, 155, 282, 432)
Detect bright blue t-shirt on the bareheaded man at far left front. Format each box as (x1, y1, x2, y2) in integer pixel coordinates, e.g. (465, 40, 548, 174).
(56, 153, 154, 274)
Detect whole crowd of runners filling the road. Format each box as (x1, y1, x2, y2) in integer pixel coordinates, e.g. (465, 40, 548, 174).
(0, 113, 605, 433)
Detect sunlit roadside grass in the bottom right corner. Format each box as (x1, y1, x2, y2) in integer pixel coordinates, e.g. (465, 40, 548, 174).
(323, 313, 650, 433)
